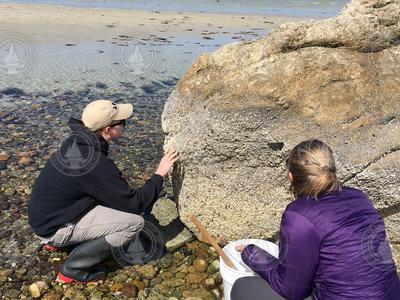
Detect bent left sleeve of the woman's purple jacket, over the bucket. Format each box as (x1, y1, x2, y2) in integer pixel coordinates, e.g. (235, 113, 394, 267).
(242, 211, 321, 300)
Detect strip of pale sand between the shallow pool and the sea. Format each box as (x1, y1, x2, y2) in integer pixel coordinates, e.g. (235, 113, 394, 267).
(0, 4, 301, 43)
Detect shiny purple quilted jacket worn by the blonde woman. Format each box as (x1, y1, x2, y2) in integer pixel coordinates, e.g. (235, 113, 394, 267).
(242, 187, 400, 300)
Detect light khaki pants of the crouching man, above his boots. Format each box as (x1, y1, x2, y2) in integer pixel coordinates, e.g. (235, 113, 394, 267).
(38, 205, 144, 247)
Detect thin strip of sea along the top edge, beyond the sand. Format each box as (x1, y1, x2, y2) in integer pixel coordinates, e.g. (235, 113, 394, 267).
(0, 0, 349, 18)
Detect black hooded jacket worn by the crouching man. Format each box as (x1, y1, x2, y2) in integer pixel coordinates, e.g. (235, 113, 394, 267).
(28, 118, 163, 237)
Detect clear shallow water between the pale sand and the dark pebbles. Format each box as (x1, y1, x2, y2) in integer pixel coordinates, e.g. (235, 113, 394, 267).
(0, 30, 266, 97)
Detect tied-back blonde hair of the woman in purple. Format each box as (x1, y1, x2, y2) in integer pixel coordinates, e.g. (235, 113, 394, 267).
(286, 139, 341, 198)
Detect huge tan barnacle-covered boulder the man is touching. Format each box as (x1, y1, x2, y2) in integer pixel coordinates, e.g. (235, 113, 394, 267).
(163, 0, 400, 258)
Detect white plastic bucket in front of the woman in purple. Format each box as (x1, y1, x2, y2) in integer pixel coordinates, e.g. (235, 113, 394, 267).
(219, 239, 279, 300)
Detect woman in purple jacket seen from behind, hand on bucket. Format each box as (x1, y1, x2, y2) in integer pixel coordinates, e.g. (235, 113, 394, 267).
(231, 140, 400, 300)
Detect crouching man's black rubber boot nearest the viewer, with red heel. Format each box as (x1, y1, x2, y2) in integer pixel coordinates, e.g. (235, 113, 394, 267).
(57, 237, 111, 283)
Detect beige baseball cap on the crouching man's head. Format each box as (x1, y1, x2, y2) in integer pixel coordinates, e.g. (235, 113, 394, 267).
(82, 100, 133, 131)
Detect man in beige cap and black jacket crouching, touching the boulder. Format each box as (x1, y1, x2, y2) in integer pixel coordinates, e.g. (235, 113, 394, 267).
(28, 100, 178, 282)
